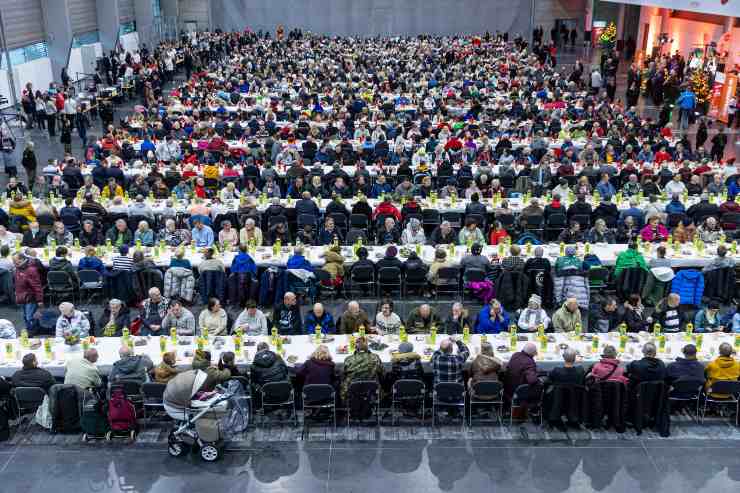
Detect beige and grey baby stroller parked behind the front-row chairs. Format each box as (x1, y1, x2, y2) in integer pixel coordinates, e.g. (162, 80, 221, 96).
(163, 370, 249, 462)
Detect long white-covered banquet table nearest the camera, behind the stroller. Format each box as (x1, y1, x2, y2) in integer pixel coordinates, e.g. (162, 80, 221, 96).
(0, 332, 740, 376)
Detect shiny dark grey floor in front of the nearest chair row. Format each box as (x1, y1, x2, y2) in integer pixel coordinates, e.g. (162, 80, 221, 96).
(0, 440, 740, 493)
